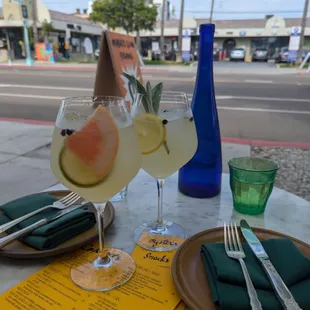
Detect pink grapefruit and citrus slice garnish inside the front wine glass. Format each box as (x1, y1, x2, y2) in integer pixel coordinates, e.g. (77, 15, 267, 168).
(59, 106, 119, 187)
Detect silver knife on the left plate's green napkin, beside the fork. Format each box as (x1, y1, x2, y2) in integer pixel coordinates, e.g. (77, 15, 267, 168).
(0, 201, 91, 249)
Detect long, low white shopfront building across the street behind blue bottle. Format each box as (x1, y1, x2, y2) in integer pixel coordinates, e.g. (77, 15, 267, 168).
(141, 16, 310, 60)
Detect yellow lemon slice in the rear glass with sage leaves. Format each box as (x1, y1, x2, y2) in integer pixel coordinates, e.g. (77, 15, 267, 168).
(134, 113, 166, 155)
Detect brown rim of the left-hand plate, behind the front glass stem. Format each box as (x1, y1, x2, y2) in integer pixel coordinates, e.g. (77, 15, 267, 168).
(0, 190, 115, 259)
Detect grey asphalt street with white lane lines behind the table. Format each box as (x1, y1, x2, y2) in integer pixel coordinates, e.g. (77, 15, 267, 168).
(0, 63, 310, 143)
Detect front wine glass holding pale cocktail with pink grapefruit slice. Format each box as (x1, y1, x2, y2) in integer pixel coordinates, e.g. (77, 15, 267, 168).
(51, 96, 141, 291)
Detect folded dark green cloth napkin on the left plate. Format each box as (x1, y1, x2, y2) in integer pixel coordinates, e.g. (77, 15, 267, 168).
(0, 193, 96, 250)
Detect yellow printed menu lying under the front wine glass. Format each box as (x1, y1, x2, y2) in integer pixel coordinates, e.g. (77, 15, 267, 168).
(0, 239, 182, 310)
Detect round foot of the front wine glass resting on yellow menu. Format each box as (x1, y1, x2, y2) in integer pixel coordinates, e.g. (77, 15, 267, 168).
(71, 248, 136, 292)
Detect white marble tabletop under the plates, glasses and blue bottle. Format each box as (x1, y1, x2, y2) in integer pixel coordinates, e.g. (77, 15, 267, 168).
(0, 171, 310, 293)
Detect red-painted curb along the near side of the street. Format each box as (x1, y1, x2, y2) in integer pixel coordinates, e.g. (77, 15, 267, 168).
(0, 117, 310, 149)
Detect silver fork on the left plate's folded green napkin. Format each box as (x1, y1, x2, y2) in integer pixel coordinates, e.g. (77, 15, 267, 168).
(0, 192, 81, 234)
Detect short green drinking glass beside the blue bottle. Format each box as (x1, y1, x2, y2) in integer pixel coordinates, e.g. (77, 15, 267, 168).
(228, 157, 279, 215)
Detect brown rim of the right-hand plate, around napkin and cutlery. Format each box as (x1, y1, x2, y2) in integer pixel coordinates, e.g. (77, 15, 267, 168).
(171, 226, 310, 310)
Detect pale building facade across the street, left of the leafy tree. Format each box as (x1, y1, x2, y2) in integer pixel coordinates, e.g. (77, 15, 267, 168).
(0, 0, 104, 61)
